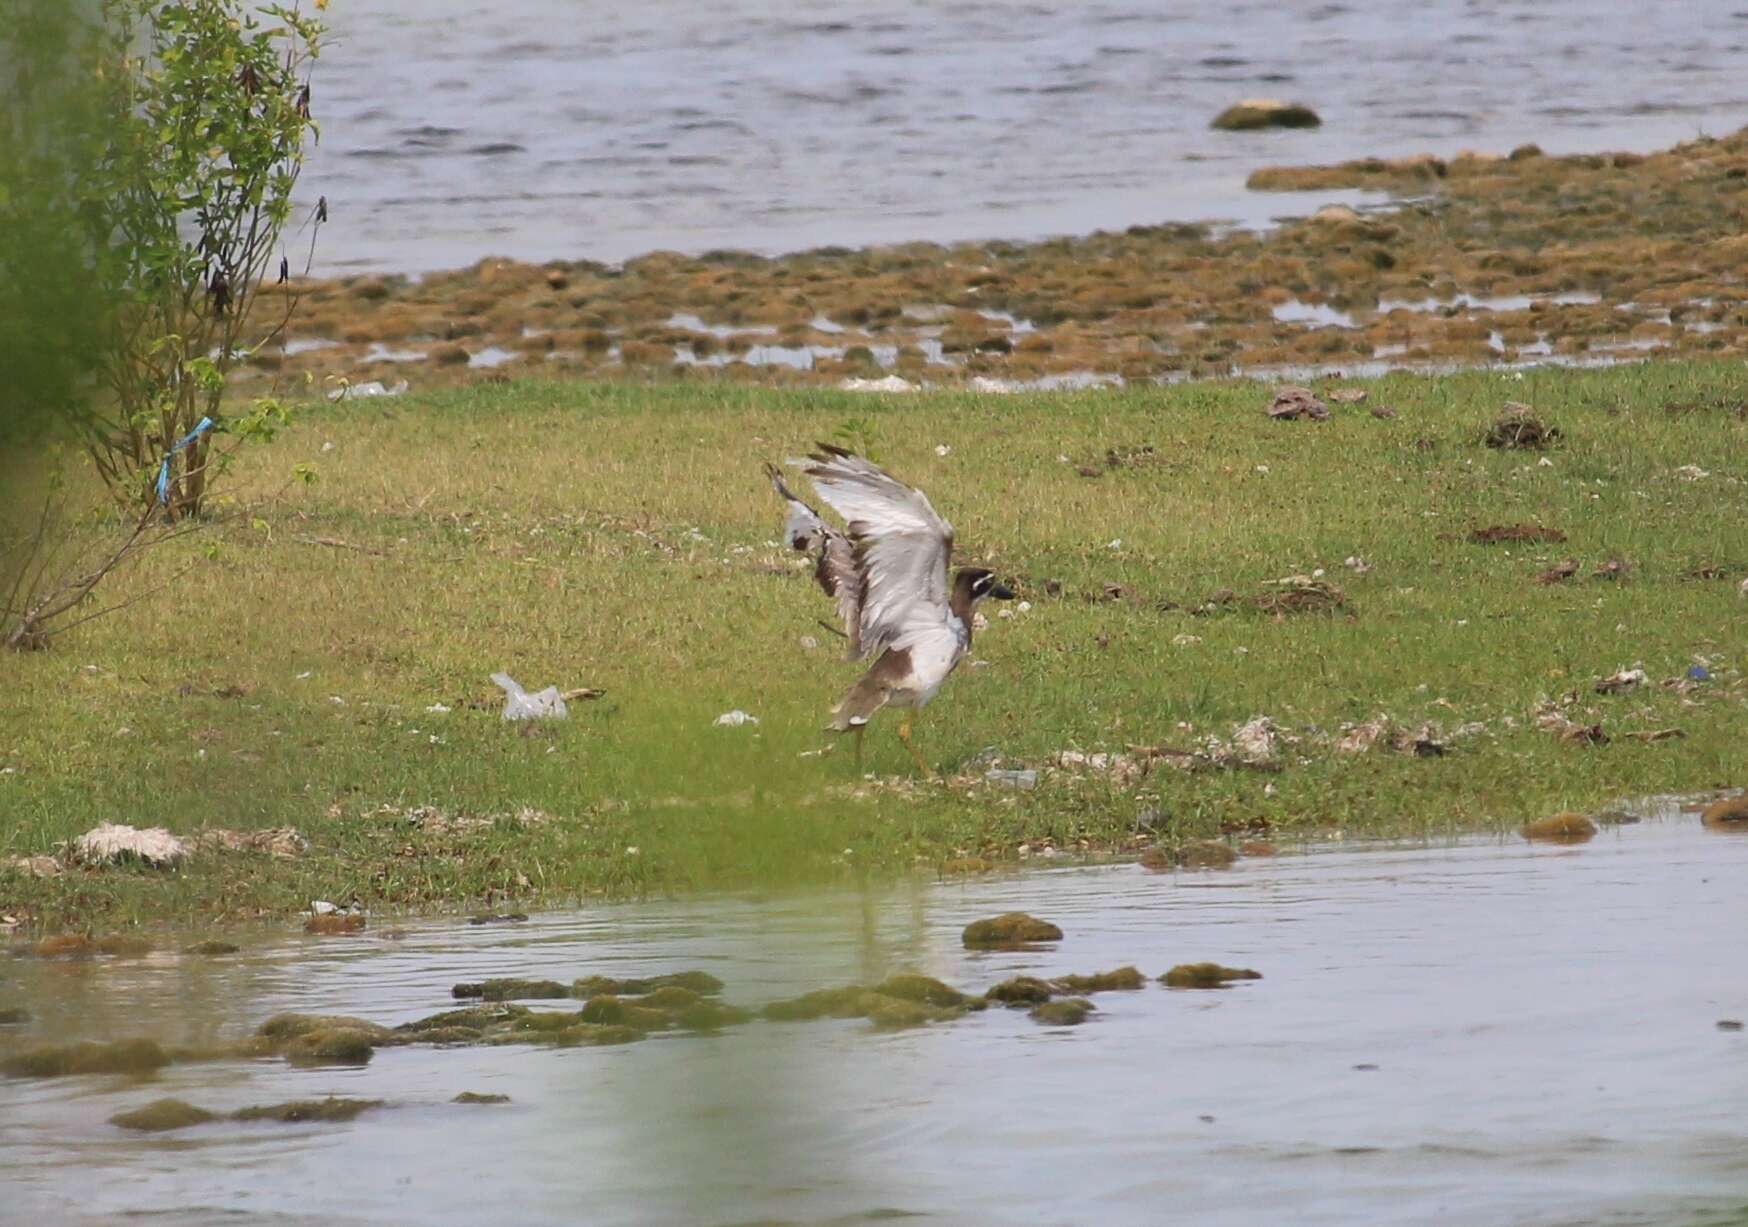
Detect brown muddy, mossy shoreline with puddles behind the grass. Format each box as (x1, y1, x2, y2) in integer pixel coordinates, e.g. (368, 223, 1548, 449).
(243, 129, 1748, 395)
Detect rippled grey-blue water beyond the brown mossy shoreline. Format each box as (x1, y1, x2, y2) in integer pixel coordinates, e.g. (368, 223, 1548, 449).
(301, 0, 1748, 273)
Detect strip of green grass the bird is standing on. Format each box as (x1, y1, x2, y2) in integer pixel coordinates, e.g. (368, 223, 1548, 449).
(0, 362, 1748, 928)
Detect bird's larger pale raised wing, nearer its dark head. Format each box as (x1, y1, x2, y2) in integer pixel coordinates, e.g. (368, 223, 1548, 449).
(802, 444, 953, 655)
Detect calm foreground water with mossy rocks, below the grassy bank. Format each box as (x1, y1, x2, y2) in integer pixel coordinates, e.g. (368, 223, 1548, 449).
(0, 815, 1748, 1227)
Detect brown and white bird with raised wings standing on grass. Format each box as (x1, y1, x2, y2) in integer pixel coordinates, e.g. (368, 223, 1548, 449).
(766, 442, 1014, 776)
